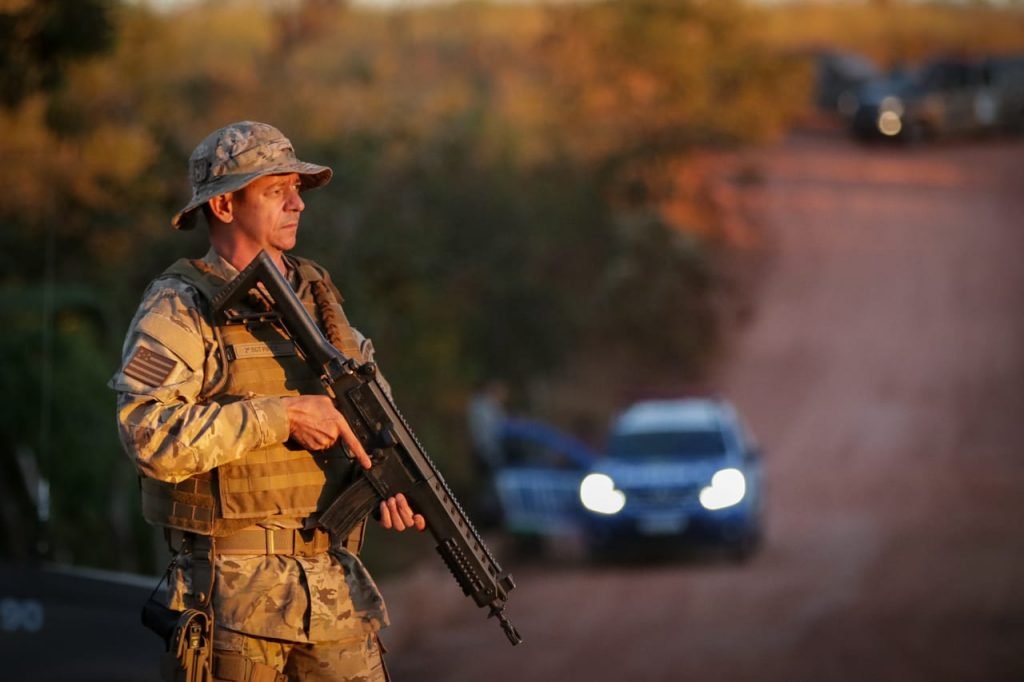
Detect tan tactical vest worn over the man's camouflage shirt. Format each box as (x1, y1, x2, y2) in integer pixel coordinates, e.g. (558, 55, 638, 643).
(141, 257, 364, 549)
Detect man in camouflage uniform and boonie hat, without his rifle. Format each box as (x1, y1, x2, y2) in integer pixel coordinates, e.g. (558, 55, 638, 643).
(111, 121, 425, 682)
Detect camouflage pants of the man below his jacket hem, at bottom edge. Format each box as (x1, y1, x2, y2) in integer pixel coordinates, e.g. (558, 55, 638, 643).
(214, 628, 390, 682)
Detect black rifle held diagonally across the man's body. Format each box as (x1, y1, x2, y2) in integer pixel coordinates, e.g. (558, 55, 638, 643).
(212, 251, 522, 645)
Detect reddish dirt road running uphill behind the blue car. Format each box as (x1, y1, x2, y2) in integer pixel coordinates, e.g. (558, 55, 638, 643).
(384, 133, 1024, 682)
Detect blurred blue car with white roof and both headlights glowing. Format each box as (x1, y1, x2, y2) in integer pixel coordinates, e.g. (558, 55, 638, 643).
(580, 398, 762, 558)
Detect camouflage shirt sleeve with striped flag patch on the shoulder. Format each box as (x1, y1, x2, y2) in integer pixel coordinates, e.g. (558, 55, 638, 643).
(110, 279, 289, 482)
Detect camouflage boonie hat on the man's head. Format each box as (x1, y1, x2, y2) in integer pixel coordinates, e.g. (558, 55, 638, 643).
(171, 121, 334, 229)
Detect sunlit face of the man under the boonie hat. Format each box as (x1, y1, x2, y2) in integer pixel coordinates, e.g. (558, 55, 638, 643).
(232, 173, 306, 253)
